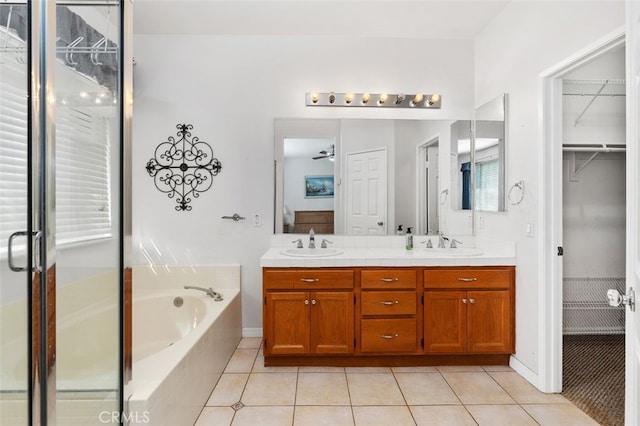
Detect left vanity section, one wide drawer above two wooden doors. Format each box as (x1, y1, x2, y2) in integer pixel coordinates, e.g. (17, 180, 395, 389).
(263, 268, 354, 356)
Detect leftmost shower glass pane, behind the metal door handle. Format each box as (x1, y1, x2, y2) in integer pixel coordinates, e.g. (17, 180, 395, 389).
(0, 2, 32, 426)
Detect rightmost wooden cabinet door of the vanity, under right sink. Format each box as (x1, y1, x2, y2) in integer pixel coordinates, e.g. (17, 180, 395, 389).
(467, 291, 513, 353)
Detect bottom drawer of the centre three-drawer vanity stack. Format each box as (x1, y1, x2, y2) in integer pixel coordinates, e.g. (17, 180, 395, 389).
(361, 319, 417, 352)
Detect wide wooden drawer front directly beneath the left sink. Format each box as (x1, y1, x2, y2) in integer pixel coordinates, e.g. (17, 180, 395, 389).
(263, 269, 353, 290)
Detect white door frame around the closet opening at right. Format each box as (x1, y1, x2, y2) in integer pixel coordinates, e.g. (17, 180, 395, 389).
(538, 27, 629, 392)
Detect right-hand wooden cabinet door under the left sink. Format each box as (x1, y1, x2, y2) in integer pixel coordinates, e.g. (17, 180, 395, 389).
(311, 291, 354, 354)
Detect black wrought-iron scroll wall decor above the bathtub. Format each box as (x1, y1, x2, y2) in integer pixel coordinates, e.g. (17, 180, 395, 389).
(146, 124, 222, 211)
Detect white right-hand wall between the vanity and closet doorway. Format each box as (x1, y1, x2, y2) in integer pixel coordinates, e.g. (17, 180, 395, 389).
(475, 1, 624, 377)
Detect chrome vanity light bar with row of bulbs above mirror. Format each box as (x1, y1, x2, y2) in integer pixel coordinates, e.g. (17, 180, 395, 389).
(305, 92, 442, 109)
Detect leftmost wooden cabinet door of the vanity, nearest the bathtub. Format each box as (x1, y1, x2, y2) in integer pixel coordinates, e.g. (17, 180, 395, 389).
(265, 292, 311, 355)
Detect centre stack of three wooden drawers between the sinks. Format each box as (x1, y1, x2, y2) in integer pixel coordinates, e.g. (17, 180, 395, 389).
(360, 268, 418, 353)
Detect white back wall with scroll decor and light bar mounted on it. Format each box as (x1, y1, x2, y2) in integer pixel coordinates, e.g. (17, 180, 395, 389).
(133, 35, 473, 329)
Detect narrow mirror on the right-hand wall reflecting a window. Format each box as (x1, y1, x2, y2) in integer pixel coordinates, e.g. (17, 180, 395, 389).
(472, 95, 507, 212)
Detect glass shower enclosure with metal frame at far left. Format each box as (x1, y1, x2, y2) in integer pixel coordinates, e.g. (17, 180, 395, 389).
(0, 0, 131, 425)
